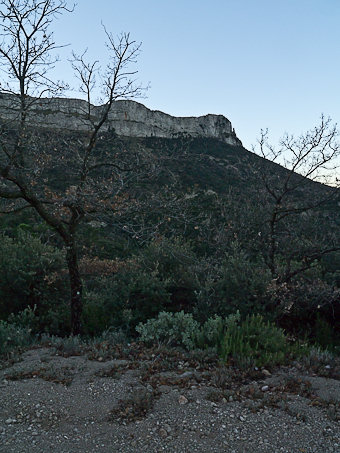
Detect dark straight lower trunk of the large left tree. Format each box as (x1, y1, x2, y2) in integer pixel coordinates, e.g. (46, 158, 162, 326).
(66, 241, 83, 335)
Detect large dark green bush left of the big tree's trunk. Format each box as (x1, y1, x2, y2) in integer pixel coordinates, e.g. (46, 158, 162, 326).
(0, 230, 69, 333)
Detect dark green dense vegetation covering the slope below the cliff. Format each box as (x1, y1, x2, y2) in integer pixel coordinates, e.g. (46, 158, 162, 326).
(0, 134, 340, 356)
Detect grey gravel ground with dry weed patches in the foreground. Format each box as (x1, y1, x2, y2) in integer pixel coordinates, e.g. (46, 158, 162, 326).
(0, 348, 340, 453)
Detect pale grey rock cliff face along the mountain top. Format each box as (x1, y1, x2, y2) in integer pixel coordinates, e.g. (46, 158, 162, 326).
(0, 93, 242, 146)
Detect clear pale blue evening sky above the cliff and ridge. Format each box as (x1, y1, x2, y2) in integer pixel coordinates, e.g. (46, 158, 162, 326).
(50, 0, 340, 149)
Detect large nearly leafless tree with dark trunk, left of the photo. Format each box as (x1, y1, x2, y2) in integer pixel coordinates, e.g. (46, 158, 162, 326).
(0, 0, 150, 335)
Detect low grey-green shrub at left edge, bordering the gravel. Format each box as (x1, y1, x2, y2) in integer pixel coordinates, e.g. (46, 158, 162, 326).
(0, 321, 33, 356)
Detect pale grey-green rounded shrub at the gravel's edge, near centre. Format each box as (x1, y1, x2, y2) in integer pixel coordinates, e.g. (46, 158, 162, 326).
(136, 311, 200, 350)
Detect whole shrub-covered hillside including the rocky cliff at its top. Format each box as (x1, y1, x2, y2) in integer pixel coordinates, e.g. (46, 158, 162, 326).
(0, 97, 340, 343)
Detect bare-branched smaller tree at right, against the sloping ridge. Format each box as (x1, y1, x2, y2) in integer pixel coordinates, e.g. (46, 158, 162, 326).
(253, 116, 340, 282)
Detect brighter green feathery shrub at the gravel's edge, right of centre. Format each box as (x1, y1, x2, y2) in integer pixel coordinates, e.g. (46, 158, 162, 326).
(221, 315, 287, 367)
